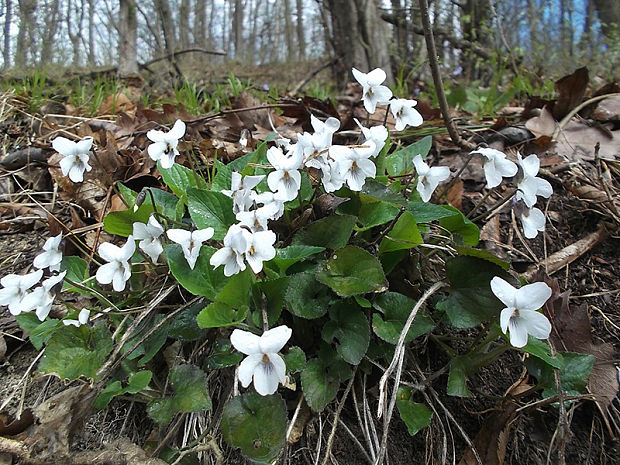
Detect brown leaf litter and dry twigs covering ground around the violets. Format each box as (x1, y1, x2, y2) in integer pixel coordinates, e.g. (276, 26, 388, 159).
(0, 62, 620, 465)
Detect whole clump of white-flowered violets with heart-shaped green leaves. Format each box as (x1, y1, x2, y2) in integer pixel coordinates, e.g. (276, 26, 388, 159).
(0, 69, 587, 462)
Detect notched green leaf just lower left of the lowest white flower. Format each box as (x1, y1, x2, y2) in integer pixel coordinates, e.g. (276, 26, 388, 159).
(146, 365, 211, 424)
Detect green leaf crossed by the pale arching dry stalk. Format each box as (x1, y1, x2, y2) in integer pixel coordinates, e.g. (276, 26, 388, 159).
(372, 292, 435, 344)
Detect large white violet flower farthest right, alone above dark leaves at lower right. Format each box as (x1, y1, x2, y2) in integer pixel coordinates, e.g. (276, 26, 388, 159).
(491, 276, 551, 347)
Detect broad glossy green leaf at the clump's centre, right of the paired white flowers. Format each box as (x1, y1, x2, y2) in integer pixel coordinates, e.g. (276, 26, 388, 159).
(316, 246, 387, 297)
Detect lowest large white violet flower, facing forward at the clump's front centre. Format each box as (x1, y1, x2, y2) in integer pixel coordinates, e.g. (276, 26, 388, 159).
(230, 325, 293, 396)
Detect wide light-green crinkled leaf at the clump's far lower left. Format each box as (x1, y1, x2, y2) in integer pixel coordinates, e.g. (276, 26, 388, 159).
(39, 322, 113, 379)
